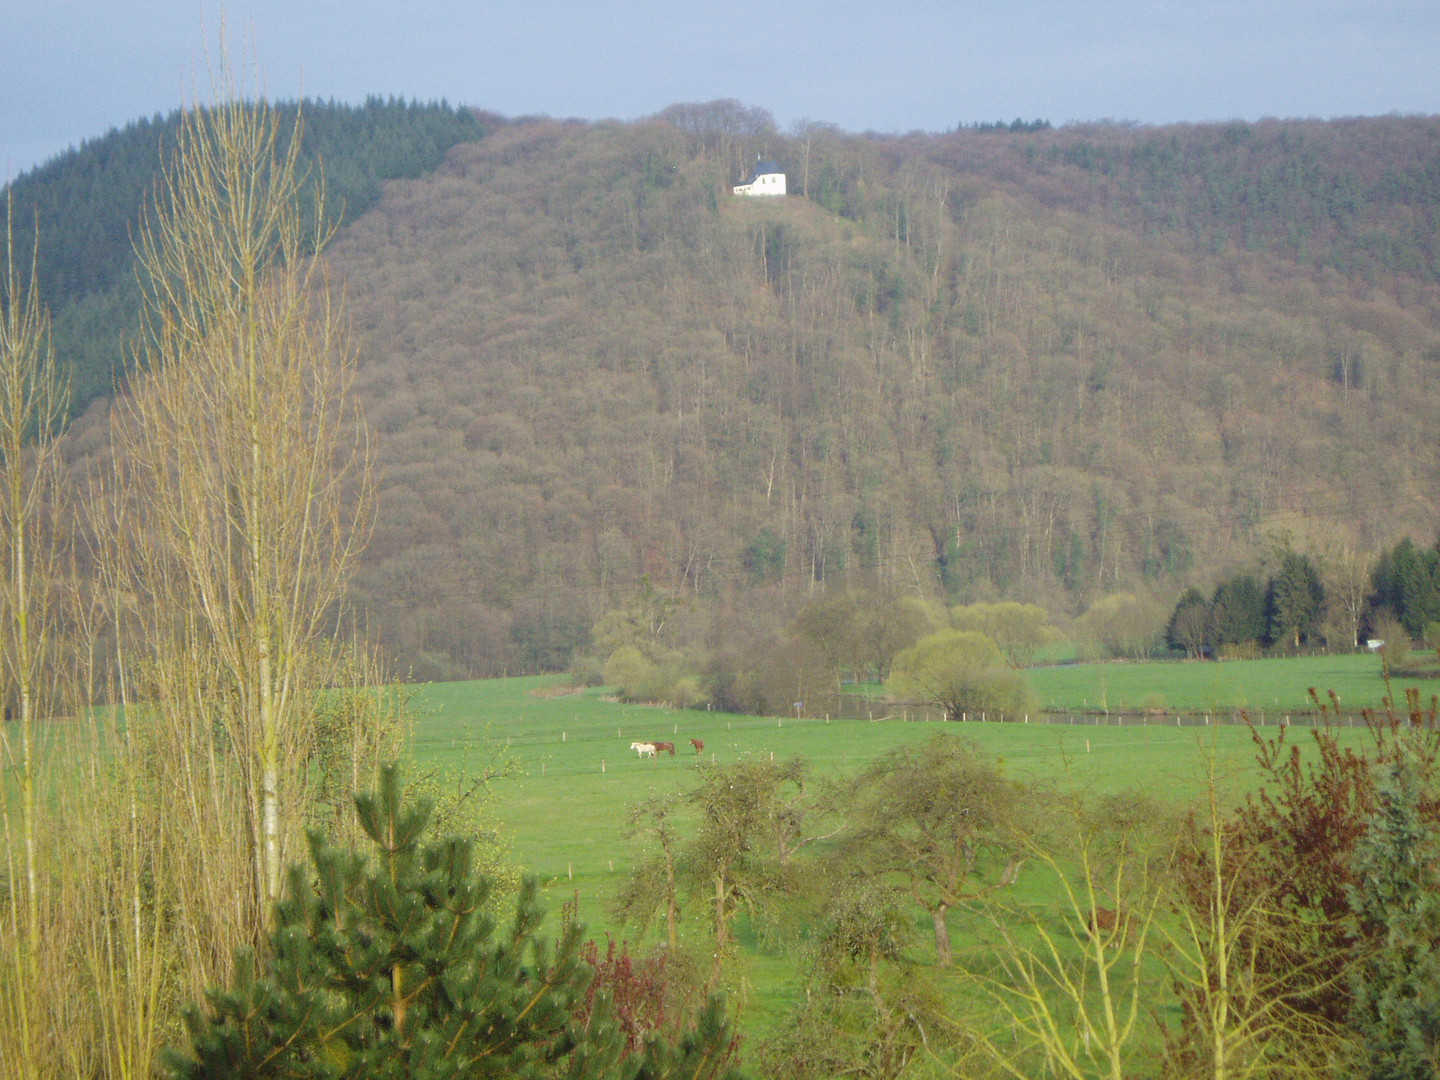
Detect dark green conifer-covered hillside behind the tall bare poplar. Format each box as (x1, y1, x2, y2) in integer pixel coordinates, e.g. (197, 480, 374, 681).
(0, 98, 484, 410)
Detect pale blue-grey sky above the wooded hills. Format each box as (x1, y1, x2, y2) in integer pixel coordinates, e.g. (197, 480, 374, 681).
(0, 0, 1440, 181)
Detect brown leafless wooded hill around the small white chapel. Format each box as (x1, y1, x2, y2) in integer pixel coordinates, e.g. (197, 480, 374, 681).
(315, 110, 1440, 677)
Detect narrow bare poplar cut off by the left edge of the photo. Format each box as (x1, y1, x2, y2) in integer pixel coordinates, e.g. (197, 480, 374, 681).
(0, 188, 66, 1067)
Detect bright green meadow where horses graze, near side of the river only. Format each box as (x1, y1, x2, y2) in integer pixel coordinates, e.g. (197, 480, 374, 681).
(413, 678, 1296, 898)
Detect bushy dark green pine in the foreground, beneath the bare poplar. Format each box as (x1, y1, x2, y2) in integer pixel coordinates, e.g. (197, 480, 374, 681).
(170, 766, 732, 1080)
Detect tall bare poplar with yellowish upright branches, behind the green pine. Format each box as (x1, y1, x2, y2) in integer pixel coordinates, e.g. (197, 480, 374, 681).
(112, 78, 370, 912)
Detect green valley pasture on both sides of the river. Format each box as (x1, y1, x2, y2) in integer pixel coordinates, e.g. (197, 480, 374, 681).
(413, 657, 1416, 1034)
